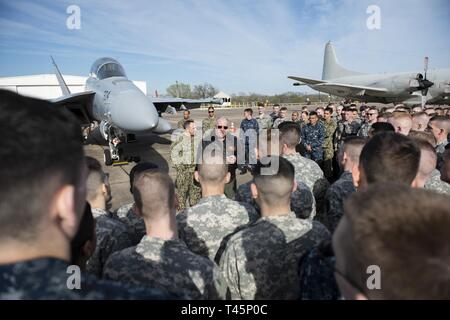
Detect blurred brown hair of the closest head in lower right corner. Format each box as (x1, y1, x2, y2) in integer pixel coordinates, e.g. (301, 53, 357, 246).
(343, 183, 450, 300)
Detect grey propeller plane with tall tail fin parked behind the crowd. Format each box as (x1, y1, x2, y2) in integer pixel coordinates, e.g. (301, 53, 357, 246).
(288, 42, 450, 106)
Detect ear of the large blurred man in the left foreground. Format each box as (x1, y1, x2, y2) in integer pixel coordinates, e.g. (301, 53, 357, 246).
(50, 185, 84, 240)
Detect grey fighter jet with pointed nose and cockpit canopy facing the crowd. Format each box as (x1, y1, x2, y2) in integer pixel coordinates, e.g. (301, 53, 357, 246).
(52, 58, 217, 166)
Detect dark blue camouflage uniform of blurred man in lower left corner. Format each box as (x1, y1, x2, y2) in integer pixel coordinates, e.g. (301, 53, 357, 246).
(0, 258, 174, 300)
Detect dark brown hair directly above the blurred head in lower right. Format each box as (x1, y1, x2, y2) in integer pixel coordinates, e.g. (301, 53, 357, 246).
(359, 132, 420, 185)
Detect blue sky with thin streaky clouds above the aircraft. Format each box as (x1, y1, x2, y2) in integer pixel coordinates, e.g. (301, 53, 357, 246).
(0, 0, 450, 94)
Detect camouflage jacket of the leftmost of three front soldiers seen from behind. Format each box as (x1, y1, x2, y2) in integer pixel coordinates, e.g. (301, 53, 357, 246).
(104, 236, 226, 299)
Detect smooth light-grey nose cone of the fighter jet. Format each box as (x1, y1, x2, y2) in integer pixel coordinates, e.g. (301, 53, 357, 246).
(111, 90, 159, 132)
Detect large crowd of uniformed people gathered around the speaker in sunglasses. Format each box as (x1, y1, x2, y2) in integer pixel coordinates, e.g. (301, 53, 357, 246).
(0, 91, 450, 300)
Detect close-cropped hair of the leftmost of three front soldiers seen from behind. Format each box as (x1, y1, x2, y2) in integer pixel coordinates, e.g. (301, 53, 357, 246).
(133, 170, 175, 219)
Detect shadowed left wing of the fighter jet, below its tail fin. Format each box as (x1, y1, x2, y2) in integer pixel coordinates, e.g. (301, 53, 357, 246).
(50, 91, 95, 126)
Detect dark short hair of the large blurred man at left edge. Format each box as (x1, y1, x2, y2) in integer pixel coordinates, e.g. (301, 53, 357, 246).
(0, 90, 84, 241)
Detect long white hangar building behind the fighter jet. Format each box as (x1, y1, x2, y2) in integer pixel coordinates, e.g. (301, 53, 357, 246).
(0, 74, 147, 99)
